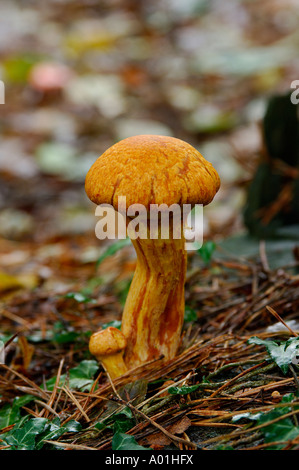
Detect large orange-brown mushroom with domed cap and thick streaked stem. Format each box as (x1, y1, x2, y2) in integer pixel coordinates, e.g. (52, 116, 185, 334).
(85, 135, 220, 369)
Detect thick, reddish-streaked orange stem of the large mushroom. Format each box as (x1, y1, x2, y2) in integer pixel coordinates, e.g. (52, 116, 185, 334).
(121, 220, 187, 369)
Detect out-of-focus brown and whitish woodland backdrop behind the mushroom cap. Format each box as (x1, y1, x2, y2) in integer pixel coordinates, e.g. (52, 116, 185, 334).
(0, 0, 299, 265)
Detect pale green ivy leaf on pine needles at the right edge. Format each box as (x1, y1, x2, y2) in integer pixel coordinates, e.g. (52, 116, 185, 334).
(248, 336, 299, 374)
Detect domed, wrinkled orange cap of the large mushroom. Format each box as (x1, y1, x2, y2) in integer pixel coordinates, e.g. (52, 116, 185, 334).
(85, 135, 220, 209)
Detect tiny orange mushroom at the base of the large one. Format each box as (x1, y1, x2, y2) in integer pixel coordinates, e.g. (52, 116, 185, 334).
(89, 326, 127, 379)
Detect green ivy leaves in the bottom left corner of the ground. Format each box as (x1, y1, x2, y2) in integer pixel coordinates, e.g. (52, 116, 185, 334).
(2, 415, 81, 450)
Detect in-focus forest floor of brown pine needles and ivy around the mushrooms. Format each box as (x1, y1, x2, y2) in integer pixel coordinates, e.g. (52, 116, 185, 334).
(0, 233, 299, 450)
